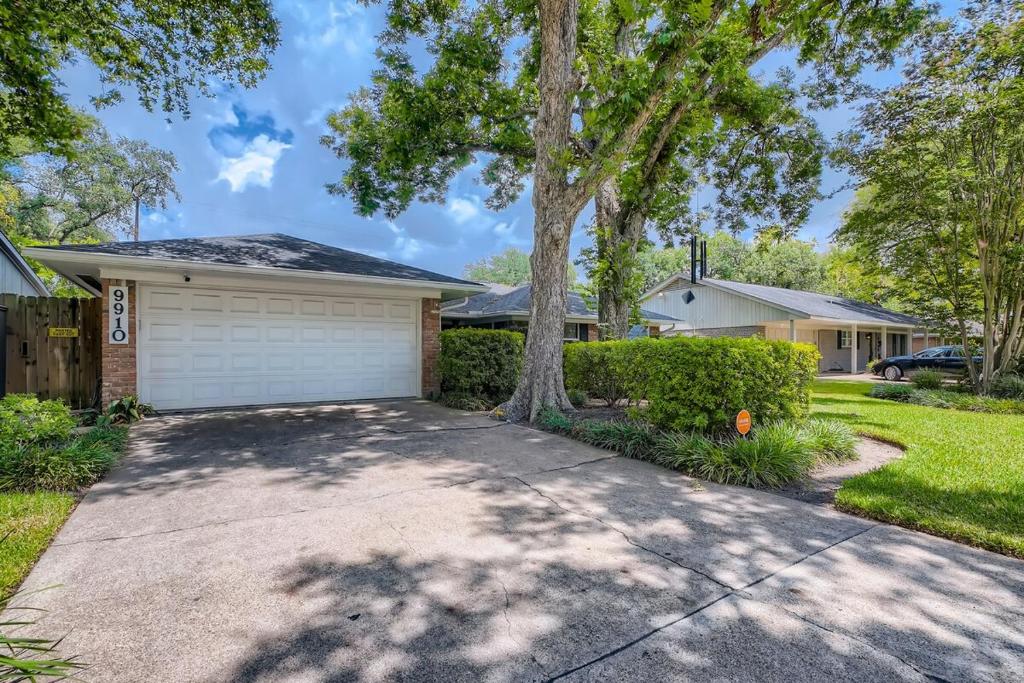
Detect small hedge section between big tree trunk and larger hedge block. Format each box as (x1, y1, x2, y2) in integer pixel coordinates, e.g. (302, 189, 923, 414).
(562, 341, 631, 405)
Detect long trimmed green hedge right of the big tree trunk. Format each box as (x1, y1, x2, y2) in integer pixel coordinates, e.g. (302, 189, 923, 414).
(564, 337, 819, 431)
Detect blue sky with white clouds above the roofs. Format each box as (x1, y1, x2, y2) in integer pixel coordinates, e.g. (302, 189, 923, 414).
(65, 0, 942, 274)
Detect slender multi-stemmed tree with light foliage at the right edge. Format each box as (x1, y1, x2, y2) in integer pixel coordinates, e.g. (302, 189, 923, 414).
(839, 2, 1024, 391)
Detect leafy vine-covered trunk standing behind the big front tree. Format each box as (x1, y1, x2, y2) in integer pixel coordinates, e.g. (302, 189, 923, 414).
(594, 178, 645, 339)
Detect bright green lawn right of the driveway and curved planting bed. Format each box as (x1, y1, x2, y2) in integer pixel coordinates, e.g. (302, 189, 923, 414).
(811, 381, 1024, 557)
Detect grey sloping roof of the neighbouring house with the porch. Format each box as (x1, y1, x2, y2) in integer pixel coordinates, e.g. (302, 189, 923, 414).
(643, 273, 926, 326)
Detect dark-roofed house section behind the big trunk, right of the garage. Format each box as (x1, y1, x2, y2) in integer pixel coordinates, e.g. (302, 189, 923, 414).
(441, 285, 678, 342)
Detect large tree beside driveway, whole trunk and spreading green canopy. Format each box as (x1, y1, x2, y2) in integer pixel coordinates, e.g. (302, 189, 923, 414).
(324, 0, 921, 419)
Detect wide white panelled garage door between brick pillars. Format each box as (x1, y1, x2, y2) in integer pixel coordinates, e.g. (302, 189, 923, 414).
(138, 286, 420, 410)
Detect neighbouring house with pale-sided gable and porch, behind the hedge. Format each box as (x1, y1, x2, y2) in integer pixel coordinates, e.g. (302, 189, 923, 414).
(641, 273, 925, 373)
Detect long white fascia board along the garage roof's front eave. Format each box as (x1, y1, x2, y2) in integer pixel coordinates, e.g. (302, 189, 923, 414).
(26, 248, 488, 293)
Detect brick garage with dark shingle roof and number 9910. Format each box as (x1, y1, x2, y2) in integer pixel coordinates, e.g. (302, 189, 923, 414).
(26, 234, 487, 410)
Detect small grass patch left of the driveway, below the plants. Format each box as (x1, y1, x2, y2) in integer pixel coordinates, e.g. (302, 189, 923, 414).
(0, 490, 75, 597)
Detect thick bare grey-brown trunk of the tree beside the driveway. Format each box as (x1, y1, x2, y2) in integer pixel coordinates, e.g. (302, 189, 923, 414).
(495, 0, 580, 422)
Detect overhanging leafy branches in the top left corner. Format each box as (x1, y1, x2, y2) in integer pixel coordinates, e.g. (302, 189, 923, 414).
(0, 0, 279, 157)
